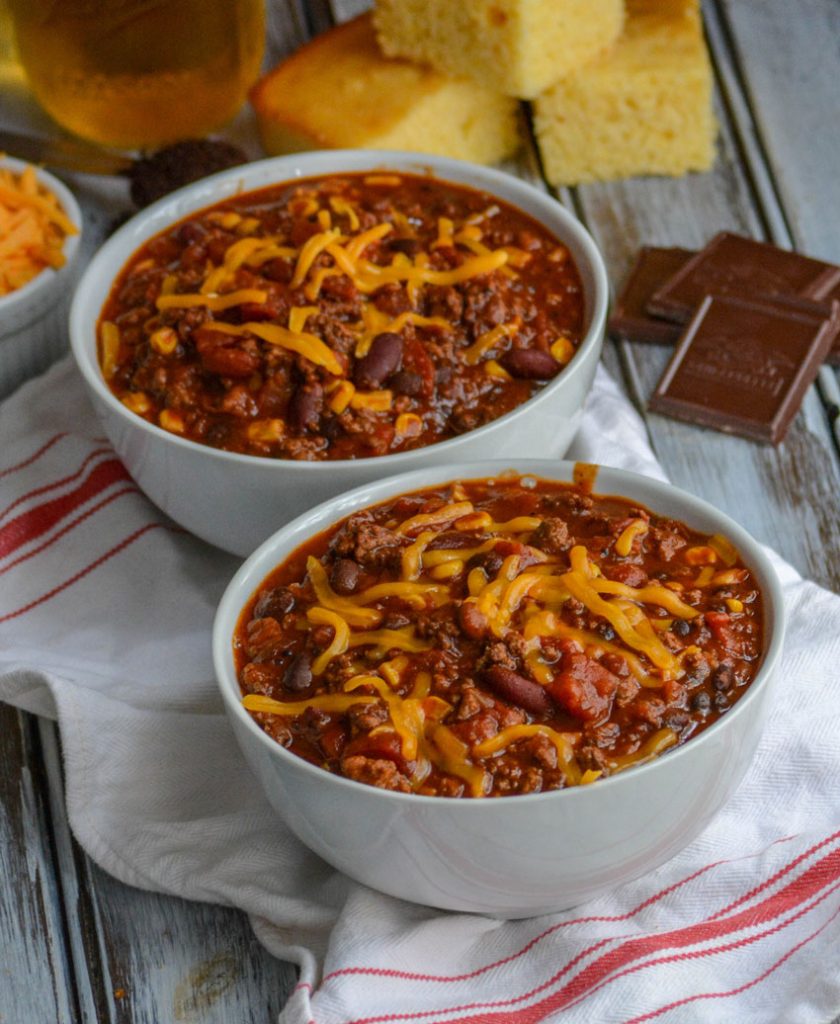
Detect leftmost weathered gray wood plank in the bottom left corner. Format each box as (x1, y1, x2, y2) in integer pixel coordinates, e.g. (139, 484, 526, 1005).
(0, 706, 77, 1024)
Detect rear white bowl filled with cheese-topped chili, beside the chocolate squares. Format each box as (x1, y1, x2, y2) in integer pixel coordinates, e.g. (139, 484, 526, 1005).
(71, 151, 608, 555)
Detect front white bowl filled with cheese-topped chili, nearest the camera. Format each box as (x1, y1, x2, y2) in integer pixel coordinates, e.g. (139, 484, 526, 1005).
(213, 460, 784, 918)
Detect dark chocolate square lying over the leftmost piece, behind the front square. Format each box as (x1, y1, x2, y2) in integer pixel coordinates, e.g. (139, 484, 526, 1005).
(647, 231, 840, 324)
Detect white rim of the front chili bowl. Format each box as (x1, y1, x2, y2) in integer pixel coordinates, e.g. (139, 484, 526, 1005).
(212, 459, 786, 814)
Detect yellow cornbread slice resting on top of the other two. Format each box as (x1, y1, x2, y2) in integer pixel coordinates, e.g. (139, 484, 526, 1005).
(374, 0, 624, 99)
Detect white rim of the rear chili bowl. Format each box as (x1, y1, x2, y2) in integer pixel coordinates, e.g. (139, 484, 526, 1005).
(70, 150, 610, 474)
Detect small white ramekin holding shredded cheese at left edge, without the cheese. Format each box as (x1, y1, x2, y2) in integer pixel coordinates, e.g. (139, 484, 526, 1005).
(0, 157, 82, 398)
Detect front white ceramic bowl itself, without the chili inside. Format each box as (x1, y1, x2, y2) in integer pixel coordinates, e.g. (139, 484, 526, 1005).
(213, 460, 784, 918)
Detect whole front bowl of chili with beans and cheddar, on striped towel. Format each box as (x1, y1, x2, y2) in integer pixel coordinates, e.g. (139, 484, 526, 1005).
(213, 460, 784, 918)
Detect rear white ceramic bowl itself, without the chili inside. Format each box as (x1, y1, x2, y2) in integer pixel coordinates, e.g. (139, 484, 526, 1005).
(70, 151, 608, 555)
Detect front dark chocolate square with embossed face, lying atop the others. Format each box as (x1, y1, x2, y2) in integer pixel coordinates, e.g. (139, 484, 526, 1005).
(649, 295, 840, 444)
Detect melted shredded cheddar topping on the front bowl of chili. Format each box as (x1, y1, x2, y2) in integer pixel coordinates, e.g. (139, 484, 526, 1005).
(237, 471, 762, 798)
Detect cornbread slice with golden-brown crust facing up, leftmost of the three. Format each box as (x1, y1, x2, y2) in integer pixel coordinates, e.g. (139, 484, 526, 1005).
(251, 14, 518, 164)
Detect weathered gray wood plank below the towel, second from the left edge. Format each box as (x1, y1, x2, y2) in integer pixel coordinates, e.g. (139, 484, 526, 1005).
(36, 720, 296, 1024)
